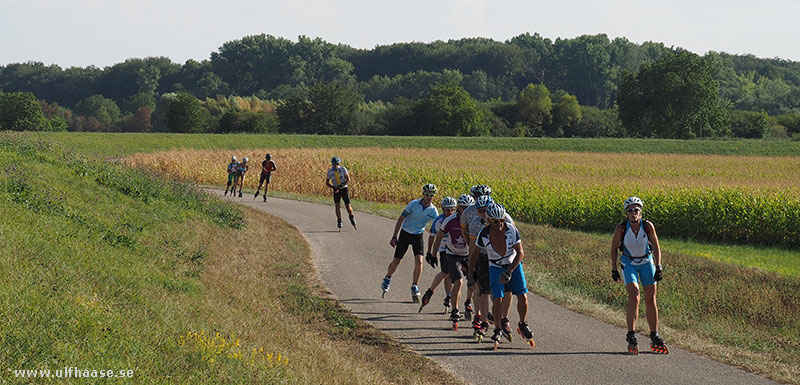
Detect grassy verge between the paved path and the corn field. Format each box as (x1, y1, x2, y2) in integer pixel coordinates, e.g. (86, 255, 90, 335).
(258, 188, 800, 384)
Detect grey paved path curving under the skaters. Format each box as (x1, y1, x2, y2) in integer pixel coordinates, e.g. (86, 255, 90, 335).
(211, 191, 774, 385)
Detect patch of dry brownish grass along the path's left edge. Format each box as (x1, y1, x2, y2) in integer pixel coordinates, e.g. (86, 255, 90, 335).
(196, 209, 461, 384)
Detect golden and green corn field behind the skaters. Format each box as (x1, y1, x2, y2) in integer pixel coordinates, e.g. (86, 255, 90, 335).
(126, 148, 800, 246)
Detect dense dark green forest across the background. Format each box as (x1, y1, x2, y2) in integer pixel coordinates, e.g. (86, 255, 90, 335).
(0, 34, 800, 138)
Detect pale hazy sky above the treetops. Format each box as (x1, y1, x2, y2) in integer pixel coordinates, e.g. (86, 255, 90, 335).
(0, 0, 800, 68)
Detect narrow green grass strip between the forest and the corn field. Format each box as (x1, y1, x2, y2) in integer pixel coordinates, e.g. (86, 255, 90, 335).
(40, 133, 800, 157)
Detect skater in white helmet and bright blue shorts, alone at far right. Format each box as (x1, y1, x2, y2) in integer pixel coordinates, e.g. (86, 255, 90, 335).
(611, 197, 669, 355)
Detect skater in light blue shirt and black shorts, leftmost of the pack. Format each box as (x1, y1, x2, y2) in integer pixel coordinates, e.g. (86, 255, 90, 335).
(381, 183, 439, 303)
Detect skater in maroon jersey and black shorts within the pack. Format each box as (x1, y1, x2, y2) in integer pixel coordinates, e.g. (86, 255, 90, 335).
(434, 194, 475, 330)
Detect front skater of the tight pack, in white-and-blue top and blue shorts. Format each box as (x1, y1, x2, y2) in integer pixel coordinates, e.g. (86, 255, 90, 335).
(475, 203, 536, 349)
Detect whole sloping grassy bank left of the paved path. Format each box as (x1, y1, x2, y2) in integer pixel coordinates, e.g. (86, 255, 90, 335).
(0, 132, 459, 384)
